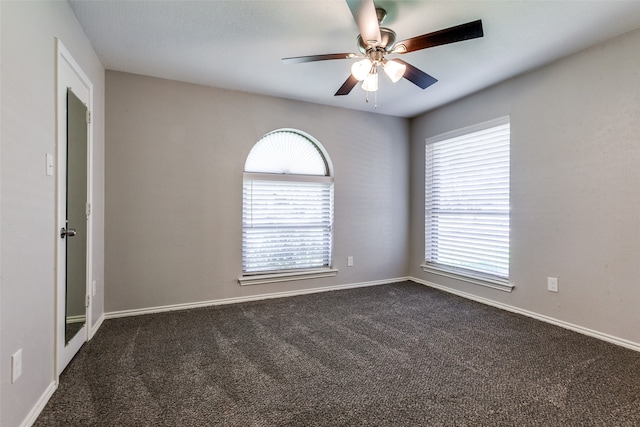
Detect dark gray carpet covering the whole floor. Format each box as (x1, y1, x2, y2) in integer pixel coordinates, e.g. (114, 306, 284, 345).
(35, 282, 640, 426)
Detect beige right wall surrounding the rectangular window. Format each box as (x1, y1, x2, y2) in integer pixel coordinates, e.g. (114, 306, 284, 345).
(410, 27, 640, 346)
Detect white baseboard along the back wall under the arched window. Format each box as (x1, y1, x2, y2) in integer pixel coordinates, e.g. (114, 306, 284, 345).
(104, 277, 412, 319)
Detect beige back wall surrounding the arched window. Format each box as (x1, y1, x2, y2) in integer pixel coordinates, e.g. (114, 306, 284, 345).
(105, 71, 409, 312)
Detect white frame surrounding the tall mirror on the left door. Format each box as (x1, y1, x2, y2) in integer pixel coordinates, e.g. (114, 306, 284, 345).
(53, 38, 93, 376)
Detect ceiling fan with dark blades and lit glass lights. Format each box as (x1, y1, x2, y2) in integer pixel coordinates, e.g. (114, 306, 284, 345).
(282, 0, 484, 96)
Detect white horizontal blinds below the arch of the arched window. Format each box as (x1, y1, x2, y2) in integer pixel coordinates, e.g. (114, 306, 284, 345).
(242, 179, 333, 273)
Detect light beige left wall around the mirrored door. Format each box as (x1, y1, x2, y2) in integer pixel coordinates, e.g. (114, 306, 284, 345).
(0, 1, 104, 426)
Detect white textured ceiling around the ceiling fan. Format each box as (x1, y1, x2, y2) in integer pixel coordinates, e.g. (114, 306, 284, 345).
(70, 0, 640, 117)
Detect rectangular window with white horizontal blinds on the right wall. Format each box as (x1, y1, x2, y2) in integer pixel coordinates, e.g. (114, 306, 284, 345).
(423, 117, 513, 291)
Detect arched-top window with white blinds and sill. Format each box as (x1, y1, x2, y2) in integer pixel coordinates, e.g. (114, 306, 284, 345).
(240, 129, 336, 284)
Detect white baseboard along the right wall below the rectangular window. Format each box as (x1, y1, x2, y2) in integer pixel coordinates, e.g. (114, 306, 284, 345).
(408, 277, 640, 351)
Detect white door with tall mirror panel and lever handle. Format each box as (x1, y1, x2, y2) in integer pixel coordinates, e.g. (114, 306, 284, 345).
(56, 42, 91, 375)
